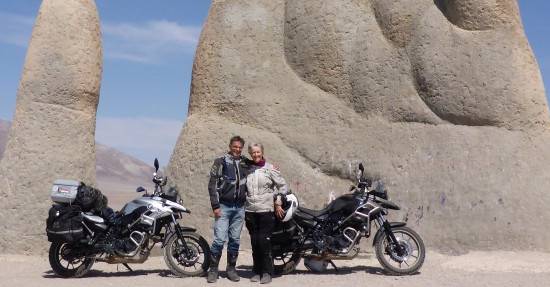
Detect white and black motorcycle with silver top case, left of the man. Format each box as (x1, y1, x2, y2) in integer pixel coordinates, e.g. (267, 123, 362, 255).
(47, 159, 210, 277)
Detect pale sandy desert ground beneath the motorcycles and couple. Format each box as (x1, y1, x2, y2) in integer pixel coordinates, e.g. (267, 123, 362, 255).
(0, 250, 550, 287)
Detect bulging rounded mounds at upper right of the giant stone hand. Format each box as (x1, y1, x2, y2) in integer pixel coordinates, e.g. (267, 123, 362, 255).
(284, 0, 549, 129)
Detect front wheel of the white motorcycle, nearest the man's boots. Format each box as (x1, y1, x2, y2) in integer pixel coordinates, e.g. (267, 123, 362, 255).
(164, 232, 210, 277)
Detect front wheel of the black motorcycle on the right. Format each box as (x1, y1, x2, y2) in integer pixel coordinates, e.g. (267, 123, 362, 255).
(374, 226, 426, 275)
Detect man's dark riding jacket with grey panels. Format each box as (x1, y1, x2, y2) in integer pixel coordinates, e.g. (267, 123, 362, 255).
(208, 154, 249, 209)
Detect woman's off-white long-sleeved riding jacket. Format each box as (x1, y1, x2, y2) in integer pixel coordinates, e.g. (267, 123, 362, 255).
(245, 162, 288, 212)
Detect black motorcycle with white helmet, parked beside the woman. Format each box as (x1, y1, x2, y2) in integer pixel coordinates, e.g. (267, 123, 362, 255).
(271, 164, 426, 275)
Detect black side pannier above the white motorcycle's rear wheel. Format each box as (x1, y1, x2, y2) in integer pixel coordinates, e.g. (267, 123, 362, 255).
(46, 204, 84, 243)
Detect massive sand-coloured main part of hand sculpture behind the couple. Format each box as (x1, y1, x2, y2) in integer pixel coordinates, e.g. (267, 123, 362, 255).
(170, 0, 550, 252)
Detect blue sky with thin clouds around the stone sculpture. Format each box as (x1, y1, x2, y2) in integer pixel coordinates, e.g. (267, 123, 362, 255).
(0, 0, 550, 164)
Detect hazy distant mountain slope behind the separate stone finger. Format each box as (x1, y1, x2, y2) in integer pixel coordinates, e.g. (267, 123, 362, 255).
(0, 120, 154, 208)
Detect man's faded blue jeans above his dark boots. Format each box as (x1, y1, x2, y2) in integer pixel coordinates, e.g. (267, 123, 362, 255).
(210, 204, 244, 255)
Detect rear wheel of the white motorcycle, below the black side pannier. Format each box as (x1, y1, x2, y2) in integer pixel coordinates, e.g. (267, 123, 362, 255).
(48, 242, 95, 278)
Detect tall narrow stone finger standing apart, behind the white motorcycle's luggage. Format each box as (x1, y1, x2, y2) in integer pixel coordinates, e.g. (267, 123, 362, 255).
(0, 0, 102, 253)
